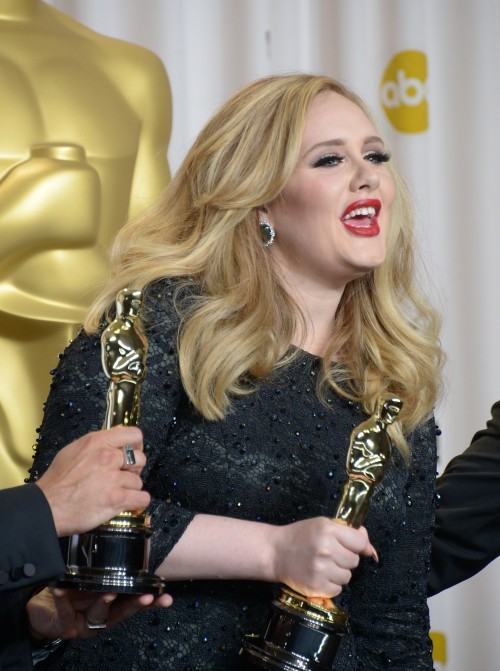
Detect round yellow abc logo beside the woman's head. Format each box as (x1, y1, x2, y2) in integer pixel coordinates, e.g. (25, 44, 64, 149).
(379, 51, 429, 133)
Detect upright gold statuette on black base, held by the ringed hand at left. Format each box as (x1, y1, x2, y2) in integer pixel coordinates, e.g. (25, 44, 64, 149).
(58, 289, 165, 595)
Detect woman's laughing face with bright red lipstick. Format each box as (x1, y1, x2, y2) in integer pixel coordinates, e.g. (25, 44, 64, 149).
(268, 91, 395, 289)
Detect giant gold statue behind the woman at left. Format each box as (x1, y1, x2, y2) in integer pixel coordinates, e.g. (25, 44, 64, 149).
(0, 0, 171, 487)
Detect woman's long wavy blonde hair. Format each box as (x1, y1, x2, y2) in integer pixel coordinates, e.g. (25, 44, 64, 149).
(85, 74, 443, 456)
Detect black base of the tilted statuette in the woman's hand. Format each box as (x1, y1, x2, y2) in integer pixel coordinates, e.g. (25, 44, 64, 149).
(240, 588, 348, 671)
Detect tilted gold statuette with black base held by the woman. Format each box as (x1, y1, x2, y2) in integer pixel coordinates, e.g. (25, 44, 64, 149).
(240, 395, 403, 671)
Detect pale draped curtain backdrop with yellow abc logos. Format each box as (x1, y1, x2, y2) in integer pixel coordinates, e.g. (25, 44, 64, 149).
(38, 0, 500, 671)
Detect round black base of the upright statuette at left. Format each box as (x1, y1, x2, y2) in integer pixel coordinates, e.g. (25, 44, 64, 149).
(57, 513, 165, 596)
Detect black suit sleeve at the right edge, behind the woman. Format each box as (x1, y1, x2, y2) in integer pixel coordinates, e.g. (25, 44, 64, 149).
(428, 401, 500, 596)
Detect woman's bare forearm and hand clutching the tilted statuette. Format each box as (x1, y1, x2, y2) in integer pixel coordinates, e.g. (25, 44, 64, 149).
(155, 514, 377, 598)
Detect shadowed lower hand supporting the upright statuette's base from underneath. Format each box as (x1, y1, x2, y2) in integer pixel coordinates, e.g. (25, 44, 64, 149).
(26, 587, 172, 639)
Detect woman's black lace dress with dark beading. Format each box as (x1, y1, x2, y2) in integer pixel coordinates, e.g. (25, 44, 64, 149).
(31, 282, 436, 671)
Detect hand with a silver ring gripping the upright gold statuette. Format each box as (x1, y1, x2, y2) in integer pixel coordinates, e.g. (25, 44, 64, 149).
(36, 426, 150, 536)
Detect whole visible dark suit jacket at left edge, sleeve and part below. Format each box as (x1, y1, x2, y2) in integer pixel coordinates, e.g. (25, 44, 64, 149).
(0, 484, 65, 671)
